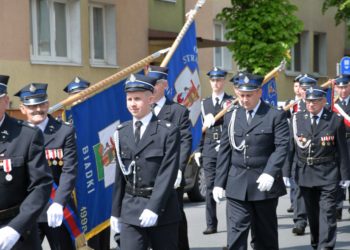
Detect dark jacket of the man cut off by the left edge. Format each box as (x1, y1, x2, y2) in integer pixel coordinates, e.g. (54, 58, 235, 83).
(0, 115, 52, 235)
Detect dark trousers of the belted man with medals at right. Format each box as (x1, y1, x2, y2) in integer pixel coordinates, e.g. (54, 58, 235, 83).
(300, 183, 337, 249)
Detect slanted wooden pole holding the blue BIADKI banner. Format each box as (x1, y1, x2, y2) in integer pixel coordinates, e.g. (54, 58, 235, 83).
(49, 48, 169, 113)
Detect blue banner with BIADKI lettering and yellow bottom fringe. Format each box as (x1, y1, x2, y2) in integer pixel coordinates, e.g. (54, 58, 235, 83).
(71, 81, 131, 239)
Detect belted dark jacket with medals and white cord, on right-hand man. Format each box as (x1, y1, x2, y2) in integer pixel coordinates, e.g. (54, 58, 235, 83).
(293, 108, 350, 187)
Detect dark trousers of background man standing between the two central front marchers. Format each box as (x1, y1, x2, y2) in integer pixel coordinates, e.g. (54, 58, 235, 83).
(203, 156, 218, 228)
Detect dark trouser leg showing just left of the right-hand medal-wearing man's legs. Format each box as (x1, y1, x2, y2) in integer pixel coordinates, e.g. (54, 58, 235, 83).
(293, 183, 307, 228)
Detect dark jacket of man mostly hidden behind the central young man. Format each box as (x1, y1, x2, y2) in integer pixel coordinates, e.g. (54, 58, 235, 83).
(157, 99, 192, 173)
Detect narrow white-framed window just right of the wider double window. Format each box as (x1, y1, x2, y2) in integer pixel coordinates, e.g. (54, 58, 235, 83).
(90, 3, 117, 66)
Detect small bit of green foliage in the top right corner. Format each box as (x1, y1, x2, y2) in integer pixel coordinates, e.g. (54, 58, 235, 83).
(322, 0, 350, 25)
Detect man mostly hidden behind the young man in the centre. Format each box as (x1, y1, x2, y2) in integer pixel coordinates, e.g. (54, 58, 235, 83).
(148, 66, 192, 250)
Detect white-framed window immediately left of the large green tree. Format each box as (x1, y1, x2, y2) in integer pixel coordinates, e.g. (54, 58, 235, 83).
(214, 23, 232, 70)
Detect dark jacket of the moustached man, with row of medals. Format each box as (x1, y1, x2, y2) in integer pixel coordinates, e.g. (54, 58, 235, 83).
(38, 115, 78, 222)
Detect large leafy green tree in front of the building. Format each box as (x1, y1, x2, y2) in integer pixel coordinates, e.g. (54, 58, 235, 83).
(217, 0, 303, 75)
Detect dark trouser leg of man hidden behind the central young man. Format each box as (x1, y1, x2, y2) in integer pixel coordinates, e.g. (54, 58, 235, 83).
(176, 187, 190, 250)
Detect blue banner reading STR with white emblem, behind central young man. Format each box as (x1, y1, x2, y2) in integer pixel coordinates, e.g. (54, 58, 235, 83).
(166, 22, 202, 150)
